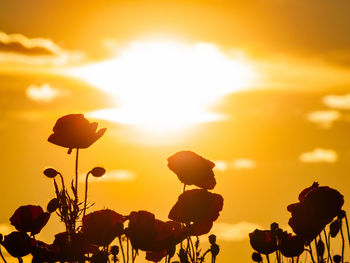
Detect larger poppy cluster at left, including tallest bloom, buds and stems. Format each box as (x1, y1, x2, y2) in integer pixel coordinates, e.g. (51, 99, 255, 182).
(0, 114, 223, 263)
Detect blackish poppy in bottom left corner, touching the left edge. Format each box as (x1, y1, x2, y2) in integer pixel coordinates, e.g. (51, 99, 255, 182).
(1, 232, 35, 258)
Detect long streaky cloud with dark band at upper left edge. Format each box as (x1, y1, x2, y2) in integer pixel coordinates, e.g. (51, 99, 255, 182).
(0, 31, 84, 65)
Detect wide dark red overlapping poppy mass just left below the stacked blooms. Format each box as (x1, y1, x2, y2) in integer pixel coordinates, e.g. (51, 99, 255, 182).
(126, 211, 187, 252)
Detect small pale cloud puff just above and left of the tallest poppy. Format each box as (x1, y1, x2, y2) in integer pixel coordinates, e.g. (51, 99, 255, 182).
(26, 83, 70, 102)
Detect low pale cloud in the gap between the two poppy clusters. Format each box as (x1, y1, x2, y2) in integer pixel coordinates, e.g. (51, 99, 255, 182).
(210, 221, 262, 241)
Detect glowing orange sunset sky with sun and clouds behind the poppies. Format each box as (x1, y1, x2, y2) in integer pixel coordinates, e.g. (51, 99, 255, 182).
(0, 0, 350, 262)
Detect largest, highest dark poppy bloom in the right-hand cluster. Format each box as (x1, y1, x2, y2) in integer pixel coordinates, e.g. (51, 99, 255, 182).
(287, 184, 344, 242)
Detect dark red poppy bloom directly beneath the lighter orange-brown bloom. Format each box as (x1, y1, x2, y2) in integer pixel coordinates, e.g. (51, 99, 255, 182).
(169, 189, 224, 230)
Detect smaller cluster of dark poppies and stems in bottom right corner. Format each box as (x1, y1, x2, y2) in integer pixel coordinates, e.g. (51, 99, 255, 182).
(249, 182, 350, 263)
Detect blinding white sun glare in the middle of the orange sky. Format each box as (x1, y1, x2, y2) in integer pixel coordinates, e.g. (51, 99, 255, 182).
(65, 41, 257, 132)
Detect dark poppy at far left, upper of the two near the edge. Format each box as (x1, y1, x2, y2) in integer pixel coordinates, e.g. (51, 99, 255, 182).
(10, 205, 50, 235)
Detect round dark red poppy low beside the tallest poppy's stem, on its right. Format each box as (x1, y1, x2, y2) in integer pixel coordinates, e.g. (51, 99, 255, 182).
(82, 209, 125, 246)
